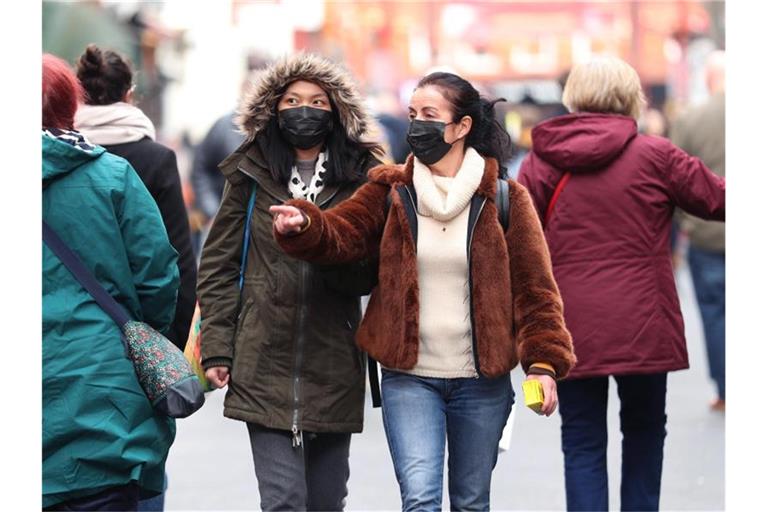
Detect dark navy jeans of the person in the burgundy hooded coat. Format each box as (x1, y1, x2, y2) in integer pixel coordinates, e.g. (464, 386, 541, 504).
(557, 373, 667, 511)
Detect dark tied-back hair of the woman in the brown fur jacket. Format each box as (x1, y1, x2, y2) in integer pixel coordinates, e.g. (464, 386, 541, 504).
(416, 72, 514, 167)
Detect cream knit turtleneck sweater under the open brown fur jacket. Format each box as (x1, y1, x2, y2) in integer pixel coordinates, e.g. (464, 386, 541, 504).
(406, 148, 485, 379)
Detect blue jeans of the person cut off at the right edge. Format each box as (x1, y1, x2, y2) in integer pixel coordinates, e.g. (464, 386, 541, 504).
(688, 247, 725, 400)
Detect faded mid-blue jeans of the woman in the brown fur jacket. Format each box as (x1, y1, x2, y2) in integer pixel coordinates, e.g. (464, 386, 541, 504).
(381, 369, 515, 511)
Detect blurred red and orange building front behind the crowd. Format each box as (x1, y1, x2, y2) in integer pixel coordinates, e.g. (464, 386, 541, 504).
(316, 0, 724, 101)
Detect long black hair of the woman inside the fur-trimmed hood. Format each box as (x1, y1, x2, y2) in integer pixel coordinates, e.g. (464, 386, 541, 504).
(257, 84, 384, 185)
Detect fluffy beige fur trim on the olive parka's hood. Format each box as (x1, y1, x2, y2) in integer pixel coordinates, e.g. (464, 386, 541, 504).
(236, 52, 370, 142)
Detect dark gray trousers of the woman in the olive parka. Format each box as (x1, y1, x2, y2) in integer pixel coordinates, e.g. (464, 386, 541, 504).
(248, 423, 352, 511)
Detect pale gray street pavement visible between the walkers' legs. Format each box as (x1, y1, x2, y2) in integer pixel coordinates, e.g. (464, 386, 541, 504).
(166, 262, 725, 510)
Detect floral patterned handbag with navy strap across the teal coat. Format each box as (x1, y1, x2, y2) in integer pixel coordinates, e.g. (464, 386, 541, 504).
(43, 221, 205, 418)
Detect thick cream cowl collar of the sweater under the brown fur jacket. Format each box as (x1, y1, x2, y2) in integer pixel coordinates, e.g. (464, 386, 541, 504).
(413, 148, 485, 222)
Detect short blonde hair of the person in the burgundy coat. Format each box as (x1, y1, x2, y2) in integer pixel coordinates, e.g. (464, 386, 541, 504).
(563, 56, 645, 119)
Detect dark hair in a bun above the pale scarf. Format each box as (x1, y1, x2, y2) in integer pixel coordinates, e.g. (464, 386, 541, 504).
(77, 44, 133, 105)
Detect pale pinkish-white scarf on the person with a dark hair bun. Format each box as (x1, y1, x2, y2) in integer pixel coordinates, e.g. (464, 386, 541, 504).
(75, 101, 155, 146)
